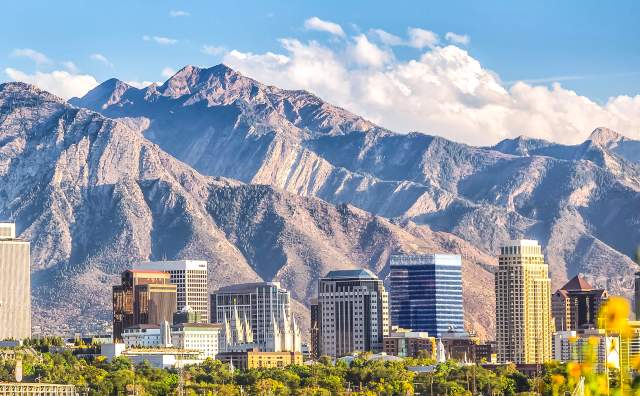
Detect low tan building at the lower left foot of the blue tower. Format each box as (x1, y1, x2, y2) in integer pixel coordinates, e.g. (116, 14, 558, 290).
(383, 326, 436, 359)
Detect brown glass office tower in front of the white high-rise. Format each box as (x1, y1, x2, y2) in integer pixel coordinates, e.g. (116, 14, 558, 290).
(113, 270, 176, 340)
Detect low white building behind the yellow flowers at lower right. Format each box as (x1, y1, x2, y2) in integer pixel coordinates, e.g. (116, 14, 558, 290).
(553, 329, 620, 373)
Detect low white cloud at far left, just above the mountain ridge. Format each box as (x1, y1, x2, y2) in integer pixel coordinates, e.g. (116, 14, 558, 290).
(4, 67, 98, 99)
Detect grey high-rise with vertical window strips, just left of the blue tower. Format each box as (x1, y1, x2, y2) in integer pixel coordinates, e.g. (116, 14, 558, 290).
(318, 269, 389, 357)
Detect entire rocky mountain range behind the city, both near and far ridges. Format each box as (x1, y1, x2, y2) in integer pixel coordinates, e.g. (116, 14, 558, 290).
(0, 65, 640, 338)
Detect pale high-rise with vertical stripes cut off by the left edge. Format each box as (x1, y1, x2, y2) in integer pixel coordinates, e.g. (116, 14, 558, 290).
(0, 223, 31, 340)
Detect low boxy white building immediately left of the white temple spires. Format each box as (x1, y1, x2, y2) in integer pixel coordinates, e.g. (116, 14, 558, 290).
(171, 323, 222, 359)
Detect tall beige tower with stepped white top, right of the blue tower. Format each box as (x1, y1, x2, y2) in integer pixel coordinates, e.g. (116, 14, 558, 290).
(495, 239, 554, 363)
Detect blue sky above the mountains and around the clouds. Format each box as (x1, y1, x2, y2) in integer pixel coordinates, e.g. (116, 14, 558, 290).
(0, 0, 640, 141)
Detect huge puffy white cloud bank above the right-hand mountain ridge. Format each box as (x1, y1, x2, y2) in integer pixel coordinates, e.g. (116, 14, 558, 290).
(223, 29, 640, 145)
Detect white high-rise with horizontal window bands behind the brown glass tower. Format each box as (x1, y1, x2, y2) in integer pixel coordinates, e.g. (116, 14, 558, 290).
(135, 260, 209, 323)
